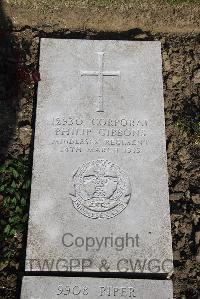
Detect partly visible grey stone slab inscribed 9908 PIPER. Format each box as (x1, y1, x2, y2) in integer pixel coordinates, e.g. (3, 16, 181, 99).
(21, 276, 173, 299)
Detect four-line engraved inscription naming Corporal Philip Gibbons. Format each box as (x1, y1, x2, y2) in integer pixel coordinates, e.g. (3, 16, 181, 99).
(47, 116, 149, 154)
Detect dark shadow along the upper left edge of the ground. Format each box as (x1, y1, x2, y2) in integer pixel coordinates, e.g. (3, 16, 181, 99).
(0, 2, 19, 163)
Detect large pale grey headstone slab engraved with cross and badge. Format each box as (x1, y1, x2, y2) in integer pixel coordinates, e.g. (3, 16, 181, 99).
(26, 39, 172, 273)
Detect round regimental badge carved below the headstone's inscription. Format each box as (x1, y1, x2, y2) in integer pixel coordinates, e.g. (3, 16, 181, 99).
(70, 159, 131, 219)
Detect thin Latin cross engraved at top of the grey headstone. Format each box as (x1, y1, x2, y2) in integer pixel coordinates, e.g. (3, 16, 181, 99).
(81, 52, 120, 112)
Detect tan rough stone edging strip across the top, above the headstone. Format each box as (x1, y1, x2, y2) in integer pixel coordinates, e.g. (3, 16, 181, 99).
(3, 0, 200, 33)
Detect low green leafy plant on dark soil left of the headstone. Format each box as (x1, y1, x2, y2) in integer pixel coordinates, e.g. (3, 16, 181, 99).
(0, 158, 30, 260)
